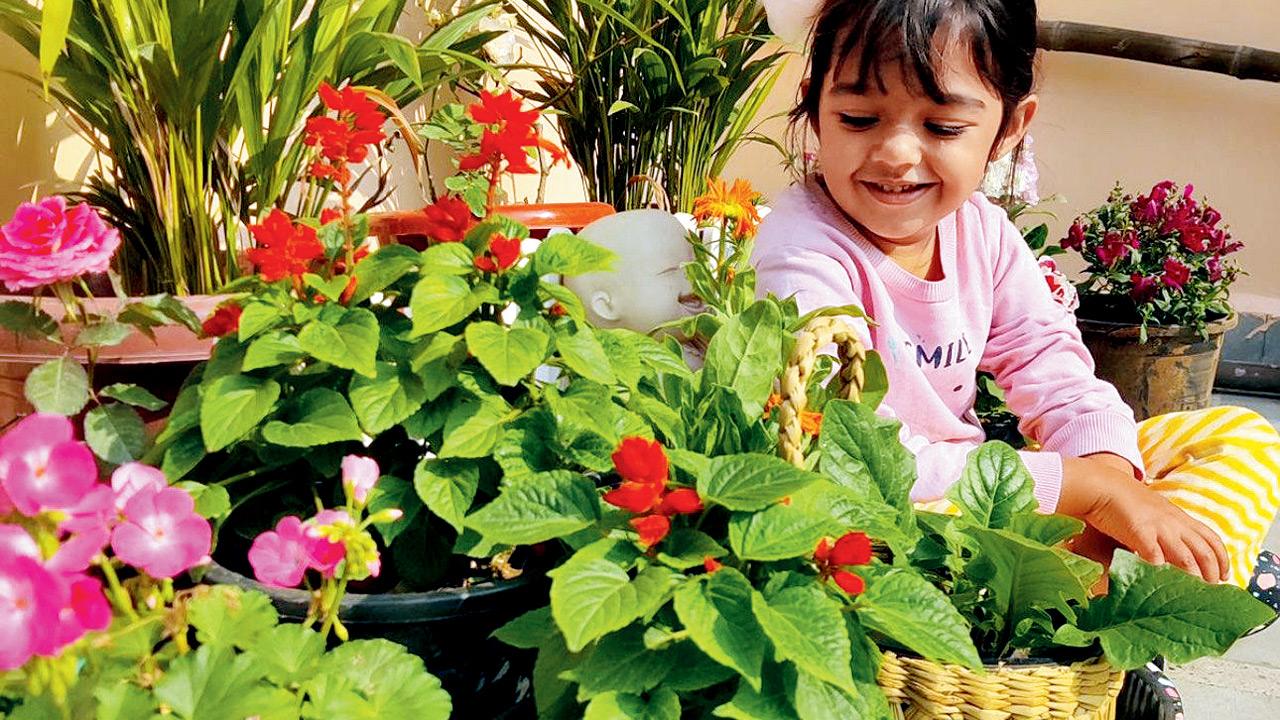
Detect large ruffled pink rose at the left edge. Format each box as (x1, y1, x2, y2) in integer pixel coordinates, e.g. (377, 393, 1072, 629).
(0, 196, 120, 292)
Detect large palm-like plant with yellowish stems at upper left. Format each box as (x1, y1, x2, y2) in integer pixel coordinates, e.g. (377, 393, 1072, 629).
(0, 0, 492, 295)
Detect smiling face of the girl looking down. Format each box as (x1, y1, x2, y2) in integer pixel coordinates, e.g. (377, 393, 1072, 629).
(815, 42, 1036, 252)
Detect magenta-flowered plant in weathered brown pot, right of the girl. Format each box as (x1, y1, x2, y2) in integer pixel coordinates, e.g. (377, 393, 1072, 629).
(1061, 181, 1243, 420)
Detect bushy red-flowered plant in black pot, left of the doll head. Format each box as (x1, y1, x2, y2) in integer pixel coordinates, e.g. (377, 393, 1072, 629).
(151, 87, 687, 717)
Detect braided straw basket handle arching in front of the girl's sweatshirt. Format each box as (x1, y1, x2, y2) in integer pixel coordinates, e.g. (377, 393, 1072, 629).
(778, 318, 867, 468)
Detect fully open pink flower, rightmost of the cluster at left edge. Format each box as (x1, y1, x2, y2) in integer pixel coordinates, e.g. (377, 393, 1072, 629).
(111, 487, 212, 578)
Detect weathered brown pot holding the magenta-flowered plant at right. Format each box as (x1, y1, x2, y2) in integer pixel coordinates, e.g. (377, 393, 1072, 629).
(1076, 297, 1238, 420)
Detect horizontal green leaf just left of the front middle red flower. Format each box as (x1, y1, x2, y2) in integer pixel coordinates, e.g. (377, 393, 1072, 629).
(463, 470, 600, 540)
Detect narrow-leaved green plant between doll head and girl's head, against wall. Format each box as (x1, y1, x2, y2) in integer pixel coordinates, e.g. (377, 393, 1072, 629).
(508, 0, 785, 210)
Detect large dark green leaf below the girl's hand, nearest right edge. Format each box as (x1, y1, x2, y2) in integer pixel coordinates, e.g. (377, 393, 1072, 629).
(1053, 550, 1275, 670)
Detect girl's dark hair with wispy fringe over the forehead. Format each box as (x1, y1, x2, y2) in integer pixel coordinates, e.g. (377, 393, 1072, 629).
(791, 0, 1036, 144)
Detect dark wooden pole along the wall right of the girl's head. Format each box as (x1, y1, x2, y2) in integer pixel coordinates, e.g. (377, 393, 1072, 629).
(1039, 20, 1280, 82)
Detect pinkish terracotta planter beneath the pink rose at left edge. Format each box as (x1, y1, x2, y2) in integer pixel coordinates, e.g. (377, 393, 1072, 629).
(0, 295, 225, 427)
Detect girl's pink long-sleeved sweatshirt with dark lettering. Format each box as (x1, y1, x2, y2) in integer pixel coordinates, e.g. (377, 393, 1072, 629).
(754, 179, 1143, 512)
